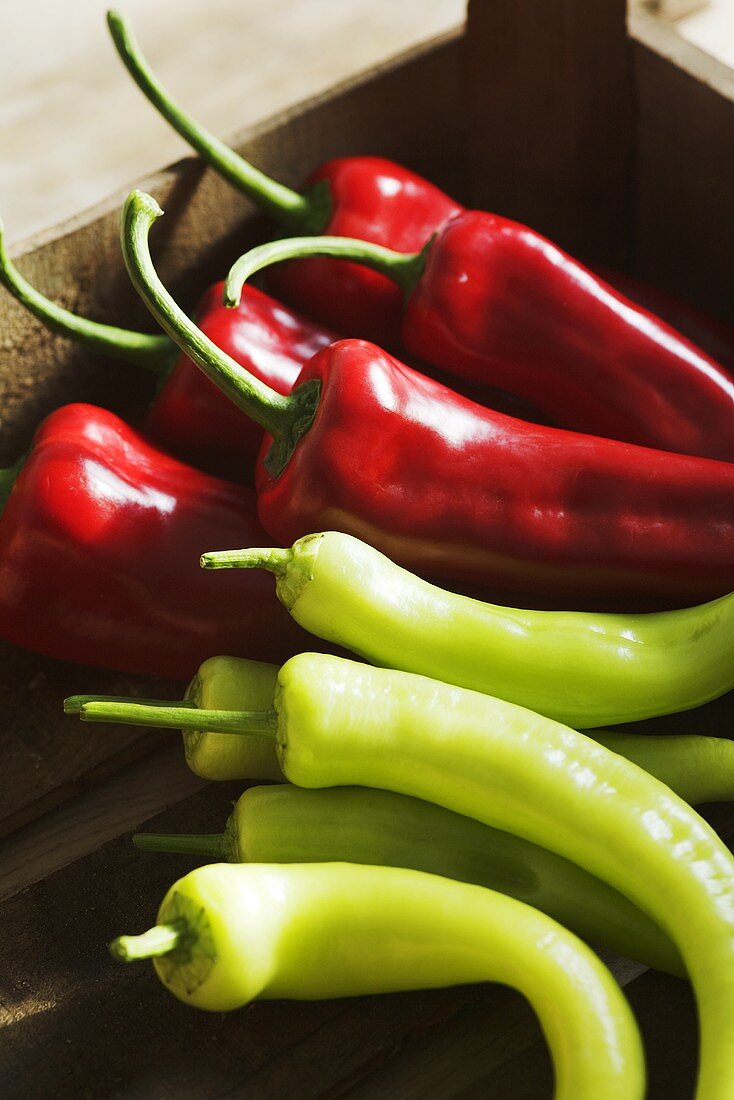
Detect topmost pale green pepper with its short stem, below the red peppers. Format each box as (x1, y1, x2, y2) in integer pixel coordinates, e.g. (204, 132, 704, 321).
(201, 531, 734, 729)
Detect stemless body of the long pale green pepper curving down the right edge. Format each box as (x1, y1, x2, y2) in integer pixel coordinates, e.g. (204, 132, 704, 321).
(275, 653, 734, 1100)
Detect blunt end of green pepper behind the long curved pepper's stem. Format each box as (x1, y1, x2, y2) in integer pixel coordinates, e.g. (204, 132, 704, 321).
(183, 657, 283, 780)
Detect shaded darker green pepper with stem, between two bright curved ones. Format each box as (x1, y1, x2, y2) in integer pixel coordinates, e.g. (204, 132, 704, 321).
(133, 783, 684, 976)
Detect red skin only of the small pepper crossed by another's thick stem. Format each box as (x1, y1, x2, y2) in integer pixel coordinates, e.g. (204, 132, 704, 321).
(143, 283, 337, 481)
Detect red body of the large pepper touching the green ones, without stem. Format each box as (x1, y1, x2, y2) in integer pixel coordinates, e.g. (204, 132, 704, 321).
(258, 340, 734, 604)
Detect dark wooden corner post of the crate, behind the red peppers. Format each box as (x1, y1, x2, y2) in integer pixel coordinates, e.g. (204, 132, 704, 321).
(467, 0, 635, 266)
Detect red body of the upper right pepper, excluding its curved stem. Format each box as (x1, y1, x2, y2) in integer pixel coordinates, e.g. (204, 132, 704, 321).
(403, 211, 734, 461)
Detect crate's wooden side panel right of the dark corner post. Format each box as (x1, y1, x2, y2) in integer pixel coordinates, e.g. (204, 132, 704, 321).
(631, 13, 734, 318)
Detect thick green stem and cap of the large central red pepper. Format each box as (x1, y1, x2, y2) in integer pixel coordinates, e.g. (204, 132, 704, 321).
(122, 191, 320, 476)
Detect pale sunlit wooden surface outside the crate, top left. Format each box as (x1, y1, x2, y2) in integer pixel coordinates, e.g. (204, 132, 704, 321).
(0, 0, 465, 241)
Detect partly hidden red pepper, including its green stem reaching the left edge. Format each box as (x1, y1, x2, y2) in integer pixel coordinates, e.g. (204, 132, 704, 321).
(0, 222, 337, 481)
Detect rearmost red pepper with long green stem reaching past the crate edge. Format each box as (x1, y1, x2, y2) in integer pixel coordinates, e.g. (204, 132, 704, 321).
(107, 11, 462, 347)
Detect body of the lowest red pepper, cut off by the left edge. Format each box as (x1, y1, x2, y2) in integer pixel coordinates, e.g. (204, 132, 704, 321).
(0, 405, 309, 680)
